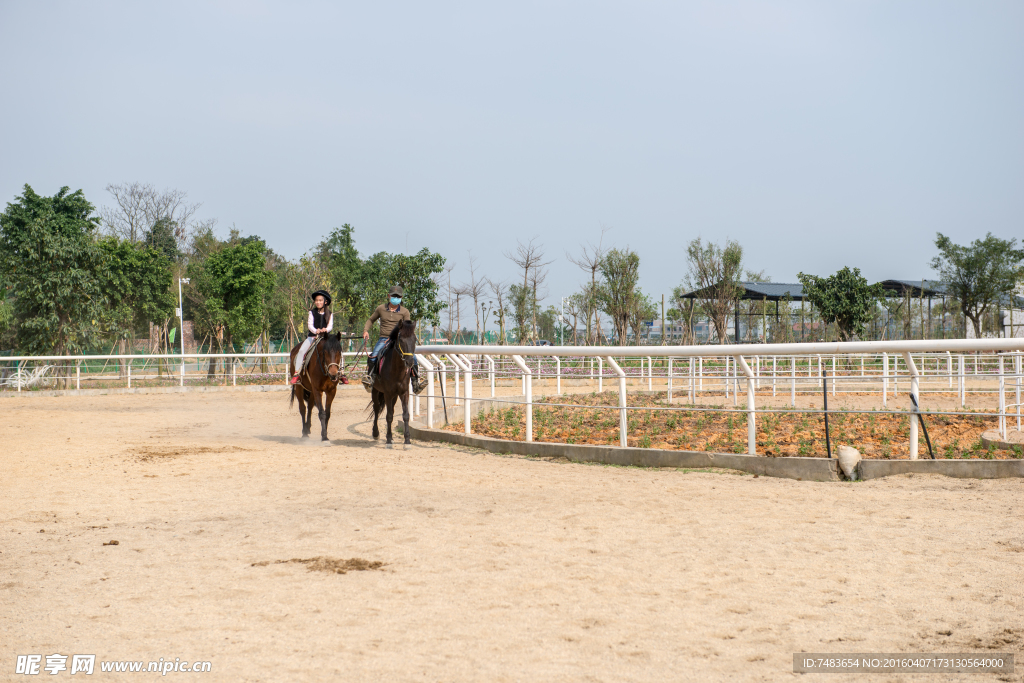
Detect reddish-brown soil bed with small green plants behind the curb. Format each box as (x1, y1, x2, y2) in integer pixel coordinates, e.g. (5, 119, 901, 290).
(447, 392, 1022, 459)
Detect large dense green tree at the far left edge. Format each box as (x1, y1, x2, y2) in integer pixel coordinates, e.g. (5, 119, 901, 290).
(0, 185, 102, 355)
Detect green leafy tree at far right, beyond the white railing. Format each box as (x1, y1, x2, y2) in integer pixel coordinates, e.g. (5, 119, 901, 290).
(932, 232, 1024, 339)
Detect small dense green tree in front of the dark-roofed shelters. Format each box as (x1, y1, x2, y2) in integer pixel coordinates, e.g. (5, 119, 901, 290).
(797, 267, 885, 341)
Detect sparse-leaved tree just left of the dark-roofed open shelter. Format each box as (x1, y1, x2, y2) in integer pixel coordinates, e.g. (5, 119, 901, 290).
(686, 238, 743, 344)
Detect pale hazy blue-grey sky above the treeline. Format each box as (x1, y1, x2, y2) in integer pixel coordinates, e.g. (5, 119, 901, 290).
(0, 0, 1024, 317)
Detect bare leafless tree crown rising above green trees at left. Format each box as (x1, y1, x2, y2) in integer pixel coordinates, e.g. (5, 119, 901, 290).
(99, 182, 216, 245)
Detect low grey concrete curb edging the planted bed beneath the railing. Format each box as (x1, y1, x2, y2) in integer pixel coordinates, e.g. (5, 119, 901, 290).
(405, 408, 1024, 481)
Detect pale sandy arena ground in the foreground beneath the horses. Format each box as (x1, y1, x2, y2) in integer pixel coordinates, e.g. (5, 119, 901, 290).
(0, 387, 1024, 682)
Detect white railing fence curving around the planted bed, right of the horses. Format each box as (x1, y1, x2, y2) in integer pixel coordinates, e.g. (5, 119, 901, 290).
(413, 339, 1024, 460)
